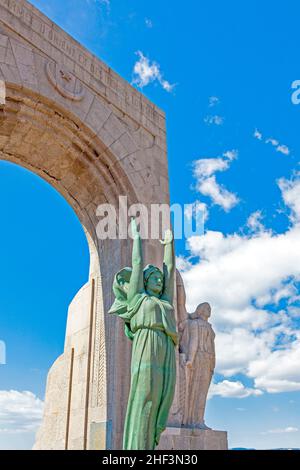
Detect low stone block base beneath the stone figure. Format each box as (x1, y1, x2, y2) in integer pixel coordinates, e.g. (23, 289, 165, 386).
(156, 427, 228, 450)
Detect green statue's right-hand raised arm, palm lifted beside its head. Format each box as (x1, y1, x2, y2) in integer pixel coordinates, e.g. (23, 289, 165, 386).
(160, 230, 175, 304)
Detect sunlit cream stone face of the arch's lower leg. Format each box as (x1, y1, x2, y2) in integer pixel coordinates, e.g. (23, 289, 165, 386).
(34, 262, 105, 450)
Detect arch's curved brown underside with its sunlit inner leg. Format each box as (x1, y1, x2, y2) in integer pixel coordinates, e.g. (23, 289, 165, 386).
(0, 85, 137, 449)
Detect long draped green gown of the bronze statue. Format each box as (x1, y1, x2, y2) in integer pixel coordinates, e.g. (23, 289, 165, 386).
(110, 274, 178, 450)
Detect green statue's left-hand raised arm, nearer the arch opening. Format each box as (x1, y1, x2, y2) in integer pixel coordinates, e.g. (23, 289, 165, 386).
(128, 218, 144, 302)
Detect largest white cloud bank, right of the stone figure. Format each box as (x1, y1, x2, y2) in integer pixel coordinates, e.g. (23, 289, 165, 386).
(181, 173, 300, 397)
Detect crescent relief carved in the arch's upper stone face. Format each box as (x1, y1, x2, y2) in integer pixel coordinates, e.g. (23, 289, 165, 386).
(46, 62, 85, 101)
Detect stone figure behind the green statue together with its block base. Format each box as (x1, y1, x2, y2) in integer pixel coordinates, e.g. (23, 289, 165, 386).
(158, 271, 228, 450)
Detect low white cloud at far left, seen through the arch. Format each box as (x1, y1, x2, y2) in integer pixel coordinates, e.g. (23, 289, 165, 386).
(0, 390, 43, 435)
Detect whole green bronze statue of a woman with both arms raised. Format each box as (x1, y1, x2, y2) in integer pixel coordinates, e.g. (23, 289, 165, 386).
(109, 219, 178, 450)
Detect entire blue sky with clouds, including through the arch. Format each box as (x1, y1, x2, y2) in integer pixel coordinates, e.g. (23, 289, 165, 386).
(0, 0, 300, 448)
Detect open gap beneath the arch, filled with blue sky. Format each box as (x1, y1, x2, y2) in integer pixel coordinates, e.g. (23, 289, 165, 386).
(0, 160, 99, 448)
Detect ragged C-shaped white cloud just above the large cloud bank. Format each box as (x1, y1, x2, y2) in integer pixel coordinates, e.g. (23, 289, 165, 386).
(194, 150, 239, 212)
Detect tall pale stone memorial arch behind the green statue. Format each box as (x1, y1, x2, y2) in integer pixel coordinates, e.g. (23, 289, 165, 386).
(0, 0, 169, 449)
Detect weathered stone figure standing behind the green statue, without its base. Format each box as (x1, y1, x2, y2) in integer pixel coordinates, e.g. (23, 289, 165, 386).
(177, 273, 216, 429)
